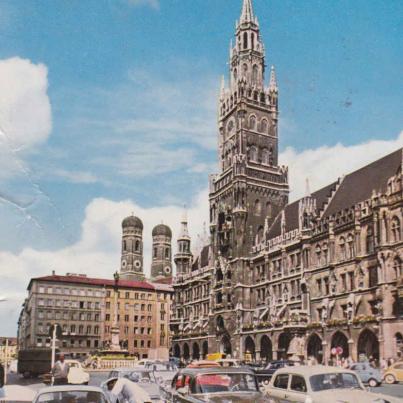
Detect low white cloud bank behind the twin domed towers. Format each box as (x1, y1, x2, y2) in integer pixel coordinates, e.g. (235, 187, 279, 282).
(0, 190, 208, 335)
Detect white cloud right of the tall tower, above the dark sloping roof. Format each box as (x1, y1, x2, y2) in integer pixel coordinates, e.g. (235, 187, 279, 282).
(279, 132, 403, 200)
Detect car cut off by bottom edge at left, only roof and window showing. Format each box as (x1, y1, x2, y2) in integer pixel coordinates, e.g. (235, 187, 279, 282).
(32, 385, 113, 403)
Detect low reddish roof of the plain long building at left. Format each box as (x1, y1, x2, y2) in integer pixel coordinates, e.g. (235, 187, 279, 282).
(28, 274, 154, 290)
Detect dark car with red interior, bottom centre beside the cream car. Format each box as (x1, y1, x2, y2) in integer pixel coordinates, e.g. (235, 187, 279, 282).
(167, 367, 269, 403)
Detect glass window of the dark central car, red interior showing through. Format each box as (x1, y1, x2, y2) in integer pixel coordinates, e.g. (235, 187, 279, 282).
(195, 373, 258, 393)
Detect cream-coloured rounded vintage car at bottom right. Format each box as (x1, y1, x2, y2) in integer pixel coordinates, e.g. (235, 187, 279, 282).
(265, 365, 401, 403)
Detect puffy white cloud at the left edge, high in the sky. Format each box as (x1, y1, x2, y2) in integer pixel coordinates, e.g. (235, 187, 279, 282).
(0, 57, 52, 179)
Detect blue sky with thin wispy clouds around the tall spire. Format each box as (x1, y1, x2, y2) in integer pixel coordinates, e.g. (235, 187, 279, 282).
(0, 0, 403, 330)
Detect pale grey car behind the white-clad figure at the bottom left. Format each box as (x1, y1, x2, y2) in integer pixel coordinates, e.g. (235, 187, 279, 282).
(101, 367, 161, 403)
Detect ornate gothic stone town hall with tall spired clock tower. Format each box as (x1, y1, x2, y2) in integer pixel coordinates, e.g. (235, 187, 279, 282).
(171, 0, 403, 362)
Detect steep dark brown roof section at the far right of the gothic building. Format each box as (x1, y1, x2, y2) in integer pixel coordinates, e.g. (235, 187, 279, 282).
(324, 148, 402, 217)
